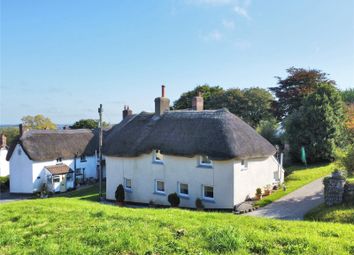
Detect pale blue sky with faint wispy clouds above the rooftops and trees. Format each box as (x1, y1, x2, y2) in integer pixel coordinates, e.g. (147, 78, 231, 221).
(0, 0, 354, 124)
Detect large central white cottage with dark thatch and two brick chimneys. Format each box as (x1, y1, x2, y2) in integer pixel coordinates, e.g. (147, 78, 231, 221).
(103, 87, 284, 209)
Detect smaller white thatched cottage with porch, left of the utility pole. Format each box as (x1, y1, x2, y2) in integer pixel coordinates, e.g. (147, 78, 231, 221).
(7, 125, 102, 193)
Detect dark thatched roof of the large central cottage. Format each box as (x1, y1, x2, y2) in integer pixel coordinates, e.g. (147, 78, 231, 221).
(103, 109, 276, 160)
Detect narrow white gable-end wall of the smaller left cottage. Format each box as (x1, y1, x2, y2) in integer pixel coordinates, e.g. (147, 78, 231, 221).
(10, 144, 33, 193)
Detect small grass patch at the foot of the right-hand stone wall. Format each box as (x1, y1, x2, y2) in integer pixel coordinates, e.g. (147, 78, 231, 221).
(305, 204, 354, 224)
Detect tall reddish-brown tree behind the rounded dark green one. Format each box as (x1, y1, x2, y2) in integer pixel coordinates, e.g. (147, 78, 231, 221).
(269, 67, 335, 119)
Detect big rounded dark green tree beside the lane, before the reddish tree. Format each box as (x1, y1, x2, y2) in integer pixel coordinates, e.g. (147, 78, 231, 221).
(285, 83, 344, 162)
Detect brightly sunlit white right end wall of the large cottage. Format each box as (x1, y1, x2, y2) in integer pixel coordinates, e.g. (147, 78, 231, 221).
(234, 156, 284, 205)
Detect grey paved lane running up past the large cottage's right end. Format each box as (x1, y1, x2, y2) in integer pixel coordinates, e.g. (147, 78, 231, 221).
(246, 178, 324, 220)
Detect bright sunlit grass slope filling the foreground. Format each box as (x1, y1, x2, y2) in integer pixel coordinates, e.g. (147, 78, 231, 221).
(0, 197, 354, 255)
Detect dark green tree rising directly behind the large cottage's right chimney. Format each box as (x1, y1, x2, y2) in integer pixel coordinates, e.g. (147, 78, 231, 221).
(173, 84, 224, 110)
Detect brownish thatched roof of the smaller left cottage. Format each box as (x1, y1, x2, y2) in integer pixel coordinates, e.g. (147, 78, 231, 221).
(6, 129, 109, 161)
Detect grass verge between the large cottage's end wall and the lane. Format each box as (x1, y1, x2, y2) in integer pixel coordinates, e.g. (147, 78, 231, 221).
(256, 163, 334, 206)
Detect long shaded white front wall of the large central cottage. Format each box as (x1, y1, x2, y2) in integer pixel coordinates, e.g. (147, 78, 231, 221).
(105, 154, 234, 208)
